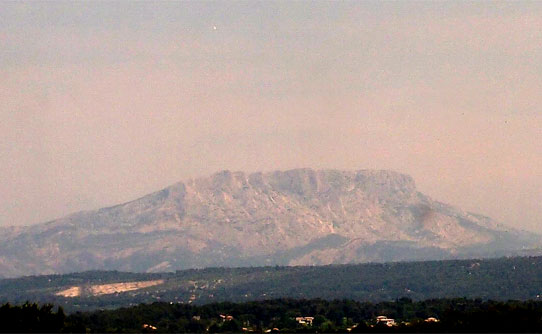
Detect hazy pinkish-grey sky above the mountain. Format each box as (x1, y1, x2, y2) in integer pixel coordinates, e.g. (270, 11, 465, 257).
(0, 1, 542, 231)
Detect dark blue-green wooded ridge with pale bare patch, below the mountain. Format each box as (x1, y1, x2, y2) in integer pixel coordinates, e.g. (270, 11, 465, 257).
(0, 257, 542, 312)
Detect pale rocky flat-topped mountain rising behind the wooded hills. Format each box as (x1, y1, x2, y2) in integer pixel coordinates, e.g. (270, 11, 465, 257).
(0, 169, 541, 277)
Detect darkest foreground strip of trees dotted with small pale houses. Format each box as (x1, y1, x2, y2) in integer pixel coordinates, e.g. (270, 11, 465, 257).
(0, 298, 542, 333)
